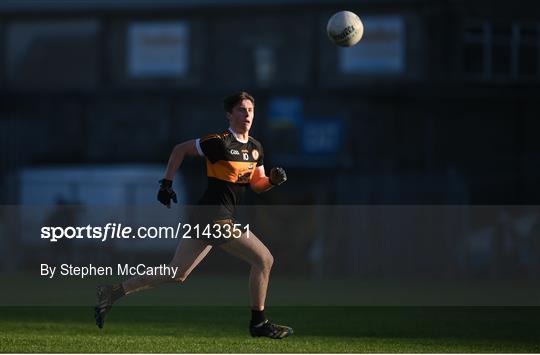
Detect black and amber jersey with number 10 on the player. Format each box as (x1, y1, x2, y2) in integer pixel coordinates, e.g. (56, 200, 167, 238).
(195, 129, 263, 218)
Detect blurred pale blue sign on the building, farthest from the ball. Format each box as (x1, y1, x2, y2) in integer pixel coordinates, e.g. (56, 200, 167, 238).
(127, 22, 189, 78)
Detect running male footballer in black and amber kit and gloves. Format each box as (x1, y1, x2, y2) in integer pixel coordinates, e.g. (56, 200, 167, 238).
(95, 92, 293, 339)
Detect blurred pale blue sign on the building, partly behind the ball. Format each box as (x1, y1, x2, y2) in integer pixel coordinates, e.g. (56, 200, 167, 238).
(338, 16, 406, 75)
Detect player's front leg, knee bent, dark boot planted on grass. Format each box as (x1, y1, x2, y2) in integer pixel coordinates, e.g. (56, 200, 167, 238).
(221, 232, 293, 339)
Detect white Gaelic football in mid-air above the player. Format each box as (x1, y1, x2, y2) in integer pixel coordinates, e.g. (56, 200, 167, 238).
(326, 11, 364, 47)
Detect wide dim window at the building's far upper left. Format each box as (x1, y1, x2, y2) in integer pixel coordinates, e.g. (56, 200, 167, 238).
(5, 20, 99, 89)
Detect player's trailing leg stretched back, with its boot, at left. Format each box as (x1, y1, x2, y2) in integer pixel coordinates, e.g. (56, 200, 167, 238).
(94, 239, 212, 328)
